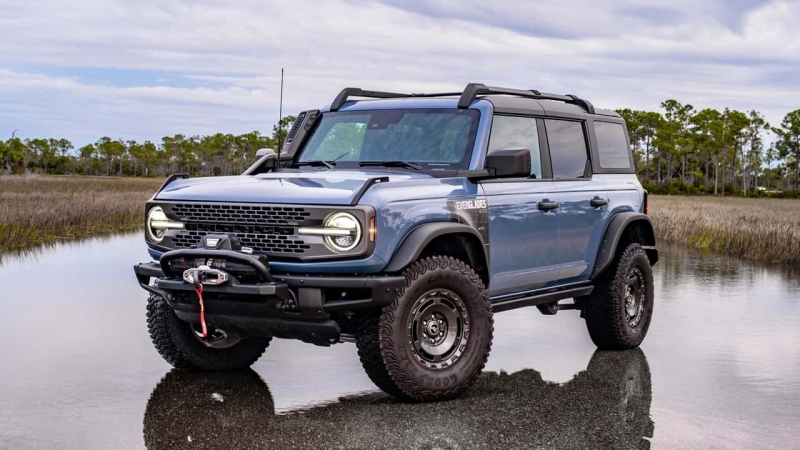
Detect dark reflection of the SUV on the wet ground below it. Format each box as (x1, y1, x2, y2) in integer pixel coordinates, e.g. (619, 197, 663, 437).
(144, 349, 654, 450)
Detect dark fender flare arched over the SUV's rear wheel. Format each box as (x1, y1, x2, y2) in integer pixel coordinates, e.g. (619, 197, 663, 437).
(589, 211, 658, 279)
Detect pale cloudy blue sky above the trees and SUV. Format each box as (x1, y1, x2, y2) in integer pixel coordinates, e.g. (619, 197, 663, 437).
(0, 0, 800, 147)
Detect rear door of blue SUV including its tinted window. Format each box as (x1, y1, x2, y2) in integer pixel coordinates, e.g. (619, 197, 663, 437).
(544, 119, 608, 284)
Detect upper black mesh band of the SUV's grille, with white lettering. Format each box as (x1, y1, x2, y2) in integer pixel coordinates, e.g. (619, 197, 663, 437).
(172, 203, 311, 226)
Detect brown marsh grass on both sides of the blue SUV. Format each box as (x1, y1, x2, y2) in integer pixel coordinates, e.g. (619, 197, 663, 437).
(0, 176, 800, 265)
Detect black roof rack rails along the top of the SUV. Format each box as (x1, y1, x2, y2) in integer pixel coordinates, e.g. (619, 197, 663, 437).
(324, 83, 595, 114)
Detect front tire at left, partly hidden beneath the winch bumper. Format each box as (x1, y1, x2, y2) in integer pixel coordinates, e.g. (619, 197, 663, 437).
(147, 294, 271, 370)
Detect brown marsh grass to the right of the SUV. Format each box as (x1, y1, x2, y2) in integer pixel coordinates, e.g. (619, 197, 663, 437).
(650, 196, 800, 265)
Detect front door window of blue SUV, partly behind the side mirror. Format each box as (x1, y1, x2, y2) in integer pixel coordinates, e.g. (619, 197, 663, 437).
(487, 116, 542, 178)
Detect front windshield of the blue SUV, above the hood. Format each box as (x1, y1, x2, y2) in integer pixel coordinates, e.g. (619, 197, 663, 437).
(296, 109, 480, 170)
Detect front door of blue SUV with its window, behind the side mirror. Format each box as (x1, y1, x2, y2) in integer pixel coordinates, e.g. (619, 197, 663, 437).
(481, 115, 560, 296)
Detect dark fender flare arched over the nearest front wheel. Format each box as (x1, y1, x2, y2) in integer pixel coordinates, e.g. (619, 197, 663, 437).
(384, 222, 489, 272)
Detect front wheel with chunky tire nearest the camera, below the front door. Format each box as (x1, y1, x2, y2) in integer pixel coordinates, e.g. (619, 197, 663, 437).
(356, 256, 494, 401)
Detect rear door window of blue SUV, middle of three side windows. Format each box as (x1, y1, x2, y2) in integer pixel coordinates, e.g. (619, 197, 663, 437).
(544, 119, 589, 179)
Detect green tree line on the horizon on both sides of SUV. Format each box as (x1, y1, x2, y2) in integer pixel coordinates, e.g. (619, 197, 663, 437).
(0, 105, 800, 195)
